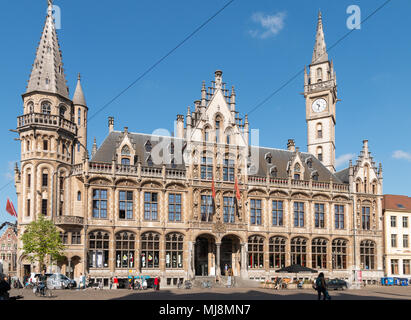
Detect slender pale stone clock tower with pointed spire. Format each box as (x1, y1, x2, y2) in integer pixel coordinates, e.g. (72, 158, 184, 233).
(304, 12, 338, 172)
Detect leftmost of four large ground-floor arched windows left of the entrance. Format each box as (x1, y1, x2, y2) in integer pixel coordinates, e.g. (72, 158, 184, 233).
(88, 231, 110, 268)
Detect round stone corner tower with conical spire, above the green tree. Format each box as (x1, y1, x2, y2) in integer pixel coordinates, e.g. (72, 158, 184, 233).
(16, 1, 78, 227)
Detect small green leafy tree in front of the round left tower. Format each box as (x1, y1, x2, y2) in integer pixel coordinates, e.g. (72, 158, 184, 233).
(21, 216, 64, 270)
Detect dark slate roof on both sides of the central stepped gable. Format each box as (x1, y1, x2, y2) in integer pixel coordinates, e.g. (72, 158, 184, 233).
(91, 131, 343, 183)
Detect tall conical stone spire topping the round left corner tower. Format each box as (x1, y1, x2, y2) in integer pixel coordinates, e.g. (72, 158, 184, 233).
(26, 1, 69, 99)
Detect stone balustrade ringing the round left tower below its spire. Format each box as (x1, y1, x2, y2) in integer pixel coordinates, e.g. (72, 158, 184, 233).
(17, 113, 77, 134)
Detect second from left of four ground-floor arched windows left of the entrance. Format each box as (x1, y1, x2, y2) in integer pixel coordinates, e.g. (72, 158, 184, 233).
(116, 232, 136, 269)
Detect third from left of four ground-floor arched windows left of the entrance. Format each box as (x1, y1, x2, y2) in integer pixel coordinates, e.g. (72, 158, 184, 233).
(141, 232, 160, 269)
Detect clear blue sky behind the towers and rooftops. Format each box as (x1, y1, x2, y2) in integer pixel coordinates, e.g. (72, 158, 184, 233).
(0, 0, 411, 225)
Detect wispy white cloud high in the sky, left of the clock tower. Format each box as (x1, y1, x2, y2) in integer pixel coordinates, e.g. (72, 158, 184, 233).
(248, 12, 286, 39)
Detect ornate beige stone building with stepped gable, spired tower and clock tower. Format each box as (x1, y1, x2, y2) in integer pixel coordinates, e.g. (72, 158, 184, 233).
(15, 3, 383, 285)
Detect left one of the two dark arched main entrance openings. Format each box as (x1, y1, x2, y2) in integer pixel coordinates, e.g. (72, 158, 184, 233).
(194, 234, 216, 277)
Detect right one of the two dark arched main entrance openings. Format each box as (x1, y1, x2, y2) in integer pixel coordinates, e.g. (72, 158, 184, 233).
(220, 235, 241, 276)
